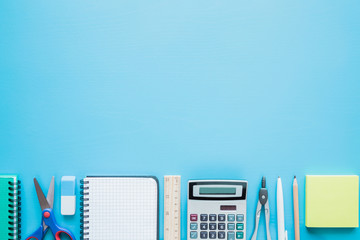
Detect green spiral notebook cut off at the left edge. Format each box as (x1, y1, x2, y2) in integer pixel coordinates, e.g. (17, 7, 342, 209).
(0, 175, 20, 239)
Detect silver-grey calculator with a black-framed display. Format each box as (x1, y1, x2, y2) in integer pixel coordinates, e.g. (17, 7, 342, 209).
(187, 180, 247, 240)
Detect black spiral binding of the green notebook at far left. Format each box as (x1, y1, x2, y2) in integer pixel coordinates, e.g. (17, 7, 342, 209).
(8, 180, 21, 240)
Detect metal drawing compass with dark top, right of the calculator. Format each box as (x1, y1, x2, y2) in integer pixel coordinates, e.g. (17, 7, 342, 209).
(251, 177, 271, 240)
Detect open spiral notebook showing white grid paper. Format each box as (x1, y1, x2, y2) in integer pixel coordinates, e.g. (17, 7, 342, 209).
(82, 177, 159, 240)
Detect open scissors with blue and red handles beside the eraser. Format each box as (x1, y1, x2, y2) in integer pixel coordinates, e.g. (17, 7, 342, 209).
(26, 177, 75, 240)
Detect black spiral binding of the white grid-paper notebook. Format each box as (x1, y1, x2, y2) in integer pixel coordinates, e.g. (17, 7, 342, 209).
(80, 179, 89, 240)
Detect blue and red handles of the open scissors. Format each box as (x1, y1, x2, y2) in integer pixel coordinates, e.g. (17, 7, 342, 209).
(26, 208, 76, 240)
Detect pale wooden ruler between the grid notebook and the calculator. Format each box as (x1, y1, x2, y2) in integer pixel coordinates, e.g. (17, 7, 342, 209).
(164, 176, 181, 240)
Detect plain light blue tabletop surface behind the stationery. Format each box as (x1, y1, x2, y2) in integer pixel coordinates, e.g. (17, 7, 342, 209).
(0, 0, 360, 240)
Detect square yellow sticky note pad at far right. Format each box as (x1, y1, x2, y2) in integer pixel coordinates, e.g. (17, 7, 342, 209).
(305, 175, 359, 228)
